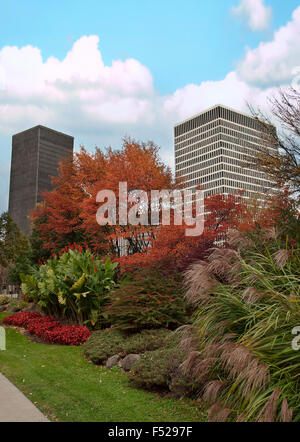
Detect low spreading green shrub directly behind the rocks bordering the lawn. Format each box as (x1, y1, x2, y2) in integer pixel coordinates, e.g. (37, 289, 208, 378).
(83, 329, 170, 364)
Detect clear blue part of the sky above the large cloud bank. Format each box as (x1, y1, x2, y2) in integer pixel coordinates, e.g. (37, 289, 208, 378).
(0, 0, 300, 94)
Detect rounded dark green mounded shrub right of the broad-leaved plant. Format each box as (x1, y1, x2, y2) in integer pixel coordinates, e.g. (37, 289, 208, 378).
(105, 268, 187, 332)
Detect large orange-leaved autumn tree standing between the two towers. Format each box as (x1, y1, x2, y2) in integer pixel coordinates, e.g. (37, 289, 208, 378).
(32, 139, 175, 256)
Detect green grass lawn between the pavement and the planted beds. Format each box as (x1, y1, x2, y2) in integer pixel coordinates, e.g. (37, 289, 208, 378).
(0, 313, 204, 422)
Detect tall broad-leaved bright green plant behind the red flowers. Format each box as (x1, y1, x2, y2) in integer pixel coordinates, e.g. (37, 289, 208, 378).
(21, 248, 117, 326)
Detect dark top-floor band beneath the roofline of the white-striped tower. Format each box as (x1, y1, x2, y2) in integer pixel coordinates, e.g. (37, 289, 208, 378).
(174, 106, 263, 137)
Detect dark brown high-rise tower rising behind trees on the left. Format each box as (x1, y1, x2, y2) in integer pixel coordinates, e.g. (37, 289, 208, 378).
(9, 126, 74, 234)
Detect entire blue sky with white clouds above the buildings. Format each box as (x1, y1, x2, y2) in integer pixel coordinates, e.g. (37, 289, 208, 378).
(0, 0, 300, 213)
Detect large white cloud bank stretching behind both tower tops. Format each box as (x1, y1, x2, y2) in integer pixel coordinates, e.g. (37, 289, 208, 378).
(0, 7, 300, 211)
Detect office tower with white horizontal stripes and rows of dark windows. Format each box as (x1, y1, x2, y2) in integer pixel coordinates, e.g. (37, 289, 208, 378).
(174, 105, 274, 197)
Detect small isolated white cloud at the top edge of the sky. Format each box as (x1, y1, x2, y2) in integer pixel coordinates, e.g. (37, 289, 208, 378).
(232, 0, 272, 31)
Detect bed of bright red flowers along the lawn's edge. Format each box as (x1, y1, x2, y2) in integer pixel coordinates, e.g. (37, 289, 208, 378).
(3, 312, 91, 345)
